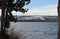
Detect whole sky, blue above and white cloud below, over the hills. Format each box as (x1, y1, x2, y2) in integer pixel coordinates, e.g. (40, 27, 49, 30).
(0, 0, 58, 16)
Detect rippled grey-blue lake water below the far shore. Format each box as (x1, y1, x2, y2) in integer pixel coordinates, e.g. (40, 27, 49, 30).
(11, 22, 58, 39)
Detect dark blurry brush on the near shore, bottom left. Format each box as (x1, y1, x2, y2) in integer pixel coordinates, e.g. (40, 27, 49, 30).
(0, 28, 25, 39)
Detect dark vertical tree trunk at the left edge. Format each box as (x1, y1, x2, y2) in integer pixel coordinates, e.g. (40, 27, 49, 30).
(1, 0, 6, 39)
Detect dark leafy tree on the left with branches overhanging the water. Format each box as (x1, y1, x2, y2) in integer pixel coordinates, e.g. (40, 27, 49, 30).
(0, 0, 30, 39)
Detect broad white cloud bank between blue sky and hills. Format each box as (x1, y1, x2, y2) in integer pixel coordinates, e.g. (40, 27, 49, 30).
(0, 5, 58, 16)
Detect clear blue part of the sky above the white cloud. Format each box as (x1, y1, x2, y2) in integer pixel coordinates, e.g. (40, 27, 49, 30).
(24, 0, 58, 8)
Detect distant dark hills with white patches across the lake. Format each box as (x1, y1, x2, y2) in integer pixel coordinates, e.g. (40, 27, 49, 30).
(0, 15, 58, 22)
